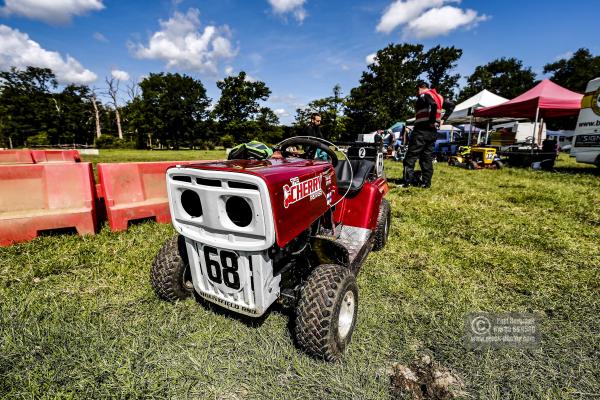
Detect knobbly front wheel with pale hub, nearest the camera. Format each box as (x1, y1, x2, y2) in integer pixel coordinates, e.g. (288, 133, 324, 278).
(294, 264, 358, 361)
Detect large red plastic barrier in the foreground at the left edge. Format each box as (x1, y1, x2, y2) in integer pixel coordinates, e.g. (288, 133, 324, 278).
(0, 163, 96, 246)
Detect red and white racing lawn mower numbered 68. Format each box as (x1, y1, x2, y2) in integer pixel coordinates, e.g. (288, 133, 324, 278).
(151, 137, 391, 361)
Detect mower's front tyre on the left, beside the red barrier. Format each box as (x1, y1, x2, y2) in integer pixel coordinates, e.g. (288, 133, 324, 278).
(150, 236, 194, 301)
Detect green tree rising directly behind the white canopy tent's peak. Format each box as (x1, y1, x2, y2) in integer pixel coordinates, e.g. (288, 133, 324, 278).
(459, 58, 535, 101)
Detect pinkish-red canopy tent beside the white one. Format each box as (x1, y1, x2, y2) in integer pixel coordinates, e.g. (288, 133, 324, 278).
(474, 79, 583, 144)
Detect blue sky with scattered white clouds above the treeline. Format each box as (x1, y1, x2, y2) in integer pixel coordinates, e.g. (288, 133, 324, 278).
(0, 0, 600, 123)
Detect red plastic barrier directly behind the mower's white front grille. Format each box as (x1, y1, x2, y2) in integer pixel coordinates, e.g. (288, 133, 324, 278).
(97, 161, 204, 231)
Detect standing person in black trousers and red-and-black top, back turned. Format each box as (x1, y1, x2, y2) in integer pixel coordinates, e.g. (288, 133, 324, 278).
(400, 81, 454, 188)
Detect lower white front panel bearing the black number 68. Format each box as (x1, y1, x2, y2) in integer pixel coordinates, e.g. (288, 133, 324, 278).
(186, 238, 281, 317)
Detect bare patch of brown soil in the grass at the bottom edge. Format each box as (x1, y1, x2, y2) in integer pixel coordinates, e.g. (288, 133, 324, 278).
(387, 355, 468, 400)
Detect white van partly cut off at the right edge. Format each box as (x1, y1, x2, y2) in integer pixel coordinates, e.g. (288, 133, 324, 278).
(571, 78, 600, 168)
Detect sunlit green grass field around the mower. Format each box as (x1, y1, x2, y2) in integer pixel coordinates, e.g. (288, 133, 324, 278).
(0, 150, 600, 399)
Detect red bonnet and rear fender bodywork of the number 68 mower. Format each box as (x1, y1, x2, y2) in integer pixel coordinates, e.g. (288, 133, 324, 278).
(189, 158, 388, 247)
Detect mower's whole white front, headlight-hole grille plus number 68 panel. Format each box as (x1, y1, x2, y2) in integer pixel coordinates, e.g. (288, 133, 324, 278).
(167, 167, 281, 317)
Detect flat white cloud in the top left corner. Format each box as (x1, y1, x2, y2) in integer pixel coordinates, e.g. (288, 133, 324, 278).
(0, 0, 104, 24)
